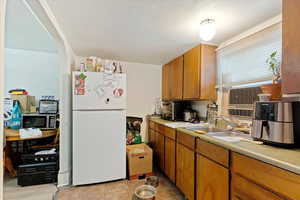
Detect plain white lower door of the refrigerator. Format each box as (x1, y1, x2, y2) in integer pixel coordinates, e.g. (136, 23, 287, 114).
(73, 111, 126, 185)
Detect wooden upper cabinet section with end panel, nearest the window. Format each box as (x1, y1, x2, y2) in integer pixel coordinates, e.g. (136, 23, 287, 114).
(183, 44, 216, 100)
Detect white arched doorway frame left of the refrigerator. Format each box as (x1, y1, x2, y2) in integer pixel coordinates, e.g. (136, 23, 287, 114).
(0, 0, 75, 189)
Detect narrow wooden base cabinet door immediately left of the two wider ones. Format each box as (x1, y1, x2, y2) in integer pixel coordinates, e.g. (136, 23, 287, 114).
(165, 137, 176, 183)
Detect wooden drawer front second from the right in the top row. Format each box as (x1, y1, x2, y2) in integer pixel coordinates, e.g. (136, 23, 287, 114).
(196, 138, 229, 168)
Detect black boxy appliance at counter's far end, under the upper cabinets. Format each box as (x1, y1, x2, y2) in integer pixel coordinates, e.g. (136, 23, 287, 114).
(161, 101, 188, 121)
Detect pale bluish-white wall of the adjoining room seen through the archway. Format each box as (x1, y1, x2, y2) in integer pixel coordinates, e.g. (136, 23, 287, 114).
(5, 49, 60, 99)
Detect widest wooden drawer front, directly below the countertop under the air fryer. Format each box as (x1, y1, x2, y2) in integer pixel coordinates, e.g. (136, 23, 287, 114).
(231, 153, 300, 200)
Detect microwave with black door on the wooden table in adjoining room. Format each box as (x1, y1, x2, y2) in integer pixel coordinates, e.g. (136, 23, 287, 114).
(22, 114, 58, 129)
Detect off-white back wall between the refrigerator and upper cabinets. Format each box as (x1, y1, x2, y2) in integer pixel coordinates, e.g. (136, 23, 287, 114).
(76, 57, 161, 140)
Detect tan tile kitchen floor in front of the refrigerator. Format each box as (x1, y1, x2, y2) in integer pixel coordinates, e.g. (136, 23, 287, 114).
(54, 175, 185, 200)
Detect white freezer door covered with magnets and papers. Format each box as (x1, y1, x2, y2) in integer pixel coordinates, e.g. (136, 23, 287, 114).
(72, 72, 127, 110)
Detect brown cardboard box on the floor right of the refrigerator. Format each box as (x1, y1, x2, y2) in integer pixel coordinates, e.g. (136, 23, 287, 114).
(127, 144, 153, 179)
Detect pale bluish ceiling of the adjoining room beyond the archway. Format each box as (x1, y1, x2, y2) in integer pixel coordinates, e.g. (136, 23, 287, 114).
(5, 0, 57, 52)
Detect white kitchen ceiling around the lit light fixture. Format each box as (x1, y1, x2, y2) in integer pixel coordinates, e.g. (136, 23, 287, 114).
(47, 0, 282, 64)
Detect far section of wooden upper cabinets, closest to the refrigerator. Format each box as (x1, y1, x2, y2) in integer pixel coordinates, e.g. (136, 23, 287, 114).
(162, 56, 183, 100)
